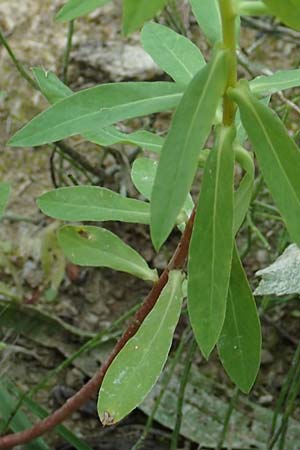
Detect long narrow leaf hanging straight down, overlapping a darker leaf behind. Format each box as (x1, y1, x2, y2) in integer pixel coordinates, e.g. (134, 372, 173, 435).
(188, 127, 235, 358)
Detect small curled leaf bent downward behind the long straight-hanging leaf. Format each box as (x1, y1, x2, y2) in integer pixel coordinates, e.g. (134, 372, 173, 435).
(233, 147, 255, 234)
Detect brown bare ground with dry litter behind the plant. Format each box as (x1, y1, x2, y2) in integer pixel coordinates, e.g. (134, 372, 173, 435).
(0, 0, 300, 450)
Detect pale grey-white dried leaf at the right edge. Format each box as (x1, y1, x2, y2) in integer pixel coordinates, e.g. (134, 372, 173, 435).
(254, 244, 300, 296)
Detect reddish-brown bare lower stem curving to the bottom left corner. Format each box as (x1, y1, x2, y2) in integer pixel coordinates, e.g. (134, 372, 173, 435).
(0, 210, 195, 450)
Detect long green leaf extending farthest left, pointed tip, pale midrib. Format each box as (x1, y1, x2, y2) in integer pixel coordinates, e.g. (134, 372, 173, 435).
(9, 82, 182, 147)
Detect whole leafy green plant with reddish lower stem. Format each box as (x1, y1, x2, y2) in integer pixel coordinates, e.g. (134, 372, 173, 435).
(0, 0, 300, 448)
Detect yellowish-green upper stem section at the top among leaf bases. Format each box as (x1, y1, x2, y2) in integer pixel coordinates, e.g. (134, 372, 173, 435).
(219, 0, 237, 126)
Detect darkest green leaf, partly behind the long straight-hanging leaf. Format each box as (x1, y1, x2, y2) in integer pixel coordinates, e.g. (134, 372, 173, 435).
(218, 248, 261, 393)
